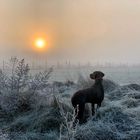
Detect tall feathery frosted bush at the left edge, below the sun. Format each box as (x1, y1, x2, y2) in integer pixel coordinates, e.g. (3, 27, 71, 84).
(0, 58, 52, 113)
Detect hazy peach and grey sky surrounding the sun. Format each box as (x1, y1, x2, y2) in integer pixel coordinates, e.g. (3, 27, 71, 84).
(0, 0, 140, 64)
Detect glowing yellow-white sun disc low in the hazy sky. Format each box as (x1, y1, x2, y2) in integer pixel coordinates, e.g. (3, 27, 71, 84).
(35, 38, 46, 49)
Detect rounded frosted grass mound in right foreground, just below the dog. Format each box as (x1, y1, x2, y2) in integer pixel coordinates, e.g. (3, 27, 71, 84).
(75, 106, 136, 140)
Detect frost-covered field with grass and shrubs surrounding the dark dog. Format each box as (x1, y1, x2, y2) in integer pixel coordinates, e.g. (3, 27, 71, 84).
(0, 58, 140, 140)
